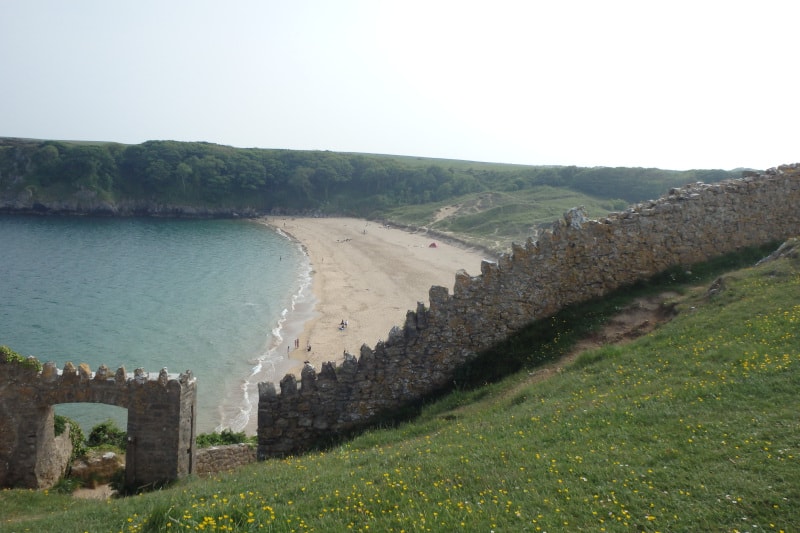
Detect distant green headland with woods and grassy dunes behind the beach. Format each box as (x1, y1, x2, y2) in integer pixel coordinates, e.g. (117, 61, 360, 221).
(0, 137, 741, 228)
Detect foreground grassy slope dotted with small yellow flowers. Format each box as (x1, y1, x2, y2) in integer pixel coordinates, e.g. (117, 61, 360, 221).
(0, 242, 800, 532)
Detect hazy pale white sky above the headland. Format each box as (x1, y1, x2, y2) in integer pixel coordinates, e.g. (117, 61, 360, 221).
(0, 0, 800, 169)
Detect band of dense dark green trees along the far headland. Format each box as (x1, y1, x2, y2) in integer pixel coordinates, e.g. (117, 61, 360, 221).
(0, 139, 738, 216)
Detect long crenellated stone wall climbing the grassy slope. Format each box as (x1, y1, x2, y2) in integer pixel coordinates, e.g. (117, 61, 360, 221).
(258, 165, 800, 459)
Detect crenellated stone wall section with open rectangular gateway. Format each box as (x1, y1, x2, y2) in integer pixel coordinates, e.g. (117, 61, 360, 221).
(0, 358, 197, 488)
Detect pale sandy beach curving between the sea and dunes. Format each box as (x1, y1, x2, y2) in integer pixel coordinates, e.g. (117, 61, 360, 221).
(267, 217, 486, 377)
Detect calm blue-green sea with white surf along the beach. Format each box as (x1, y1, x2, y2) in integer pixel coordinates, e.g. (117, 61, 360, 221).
(0, 215, 314, 434)
